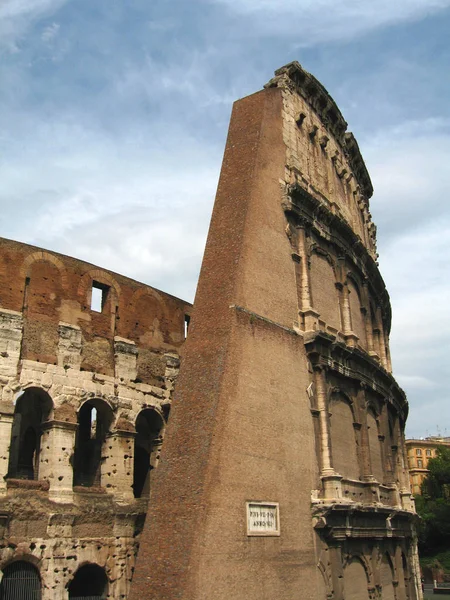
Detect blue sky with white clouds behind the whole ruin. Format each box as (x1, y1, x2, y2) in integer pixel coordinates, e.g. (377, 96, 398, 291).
(0, 0, 450, 437)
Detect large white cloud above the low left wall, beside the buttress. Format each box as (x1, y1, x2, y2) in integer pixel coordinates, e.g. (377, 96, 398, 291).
(0, 112, 222, 301)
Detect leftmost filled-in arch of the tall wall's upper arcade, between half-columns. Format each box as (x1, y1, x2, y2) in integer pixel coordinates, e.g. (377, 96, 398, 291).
(310, 246, 341, 331)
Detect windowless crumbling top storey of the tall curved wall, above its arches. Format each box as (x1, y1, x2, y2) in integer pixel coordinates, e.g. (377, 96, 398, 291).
(265, 62, 378, 260)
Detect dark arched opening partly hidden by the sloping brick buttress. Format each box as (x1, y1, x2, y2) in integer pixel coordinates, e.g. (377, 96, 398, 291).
(133, 408, 165, 498)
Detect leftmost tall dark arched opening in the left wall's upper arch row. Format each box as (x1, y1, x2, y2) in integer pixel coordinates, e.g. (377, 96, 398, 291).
(8, 388, 53, 479)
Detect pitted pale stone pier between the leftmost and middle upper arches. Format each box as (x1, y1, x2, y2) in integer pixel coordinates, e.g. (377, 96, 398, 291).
(39, 421, 78, 504)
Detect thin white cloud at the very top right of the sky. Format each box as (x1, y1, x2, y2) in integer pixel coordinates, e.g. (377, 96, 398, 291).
(205, 0, 450, 42)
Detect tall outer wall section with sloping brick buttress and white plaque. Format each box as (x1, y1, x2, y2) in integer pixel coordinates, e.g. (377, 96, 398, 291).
(131, 63, 421, 600)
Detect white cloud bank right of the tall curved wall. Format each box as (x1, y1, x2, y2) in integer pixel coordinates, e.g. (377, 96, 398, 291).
(361, 117, 450, 436)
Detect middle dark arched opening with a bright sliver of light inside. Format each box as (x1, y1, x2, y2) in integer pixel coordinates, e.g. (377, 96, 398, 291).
(73, 399, 113, 487)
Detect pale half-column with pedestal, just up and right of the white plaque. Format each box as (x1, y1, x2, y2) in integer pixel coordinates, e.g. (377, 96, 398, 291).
(314, 367, 342, 499)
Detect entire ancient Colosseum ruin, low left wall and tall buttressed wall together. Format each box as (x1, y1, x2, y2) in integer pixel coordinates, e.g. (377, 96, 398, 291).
(0, 62, 422, 600)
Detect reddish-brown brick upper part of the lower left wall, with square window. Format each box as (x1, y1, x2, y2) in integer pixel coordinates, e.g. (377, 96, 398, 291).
(0, 239, 191, 384)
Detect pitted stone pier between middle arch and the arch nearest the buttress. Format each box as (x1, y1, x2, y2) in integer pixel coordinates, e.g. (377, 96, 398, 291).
(101, 429, 136, 504)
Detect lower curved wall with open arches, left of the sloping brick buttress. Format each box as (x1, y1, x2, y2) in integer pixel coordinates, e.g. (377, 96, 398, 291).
(0, 240, 191, 600)
